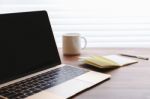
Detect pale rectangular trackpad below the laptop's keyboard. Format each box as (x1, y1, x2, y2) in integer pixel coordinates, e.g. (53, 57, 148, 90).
(45, 79, 93, 98)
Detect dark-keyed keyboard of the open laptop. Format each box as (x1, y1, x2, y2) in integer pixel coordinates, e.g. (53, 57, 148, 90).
(0, 66, 88, 99)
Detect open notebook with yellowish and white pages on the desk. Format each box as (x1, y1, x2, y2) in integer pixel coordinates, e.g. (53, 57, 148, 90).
(80, 55, 138, 68)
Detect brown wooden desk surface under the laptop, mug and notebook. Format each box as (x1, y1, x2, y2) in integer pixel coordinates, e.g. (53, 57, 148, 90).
(59, 48, 150, 99)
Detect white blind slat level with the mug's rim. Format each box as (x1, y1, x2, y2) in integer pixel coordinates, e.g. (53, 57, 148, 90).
(54, 30, 150, 37)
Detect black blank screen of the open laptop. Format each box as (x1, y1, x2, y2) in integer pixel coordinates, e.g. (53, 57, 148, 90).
(0, 11, 61, 83)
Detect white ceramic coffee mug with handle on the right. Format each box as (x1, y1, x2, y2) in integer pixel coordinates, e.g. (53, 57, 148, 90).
(63, 33, 87, 55)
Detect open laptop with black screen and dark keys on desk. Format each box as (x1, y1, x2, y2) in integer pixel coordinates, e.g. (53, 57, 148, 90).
(0, 11, 110, 99)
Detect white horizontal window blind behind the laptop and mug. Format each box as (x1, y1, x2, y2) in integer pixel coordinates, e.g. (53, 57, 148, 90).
(0, 0, 150, 47)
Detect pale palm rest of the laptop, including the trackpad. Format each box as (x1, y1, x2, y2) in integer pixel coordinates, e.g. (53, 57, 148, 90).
(26, 66, 111, 99)
